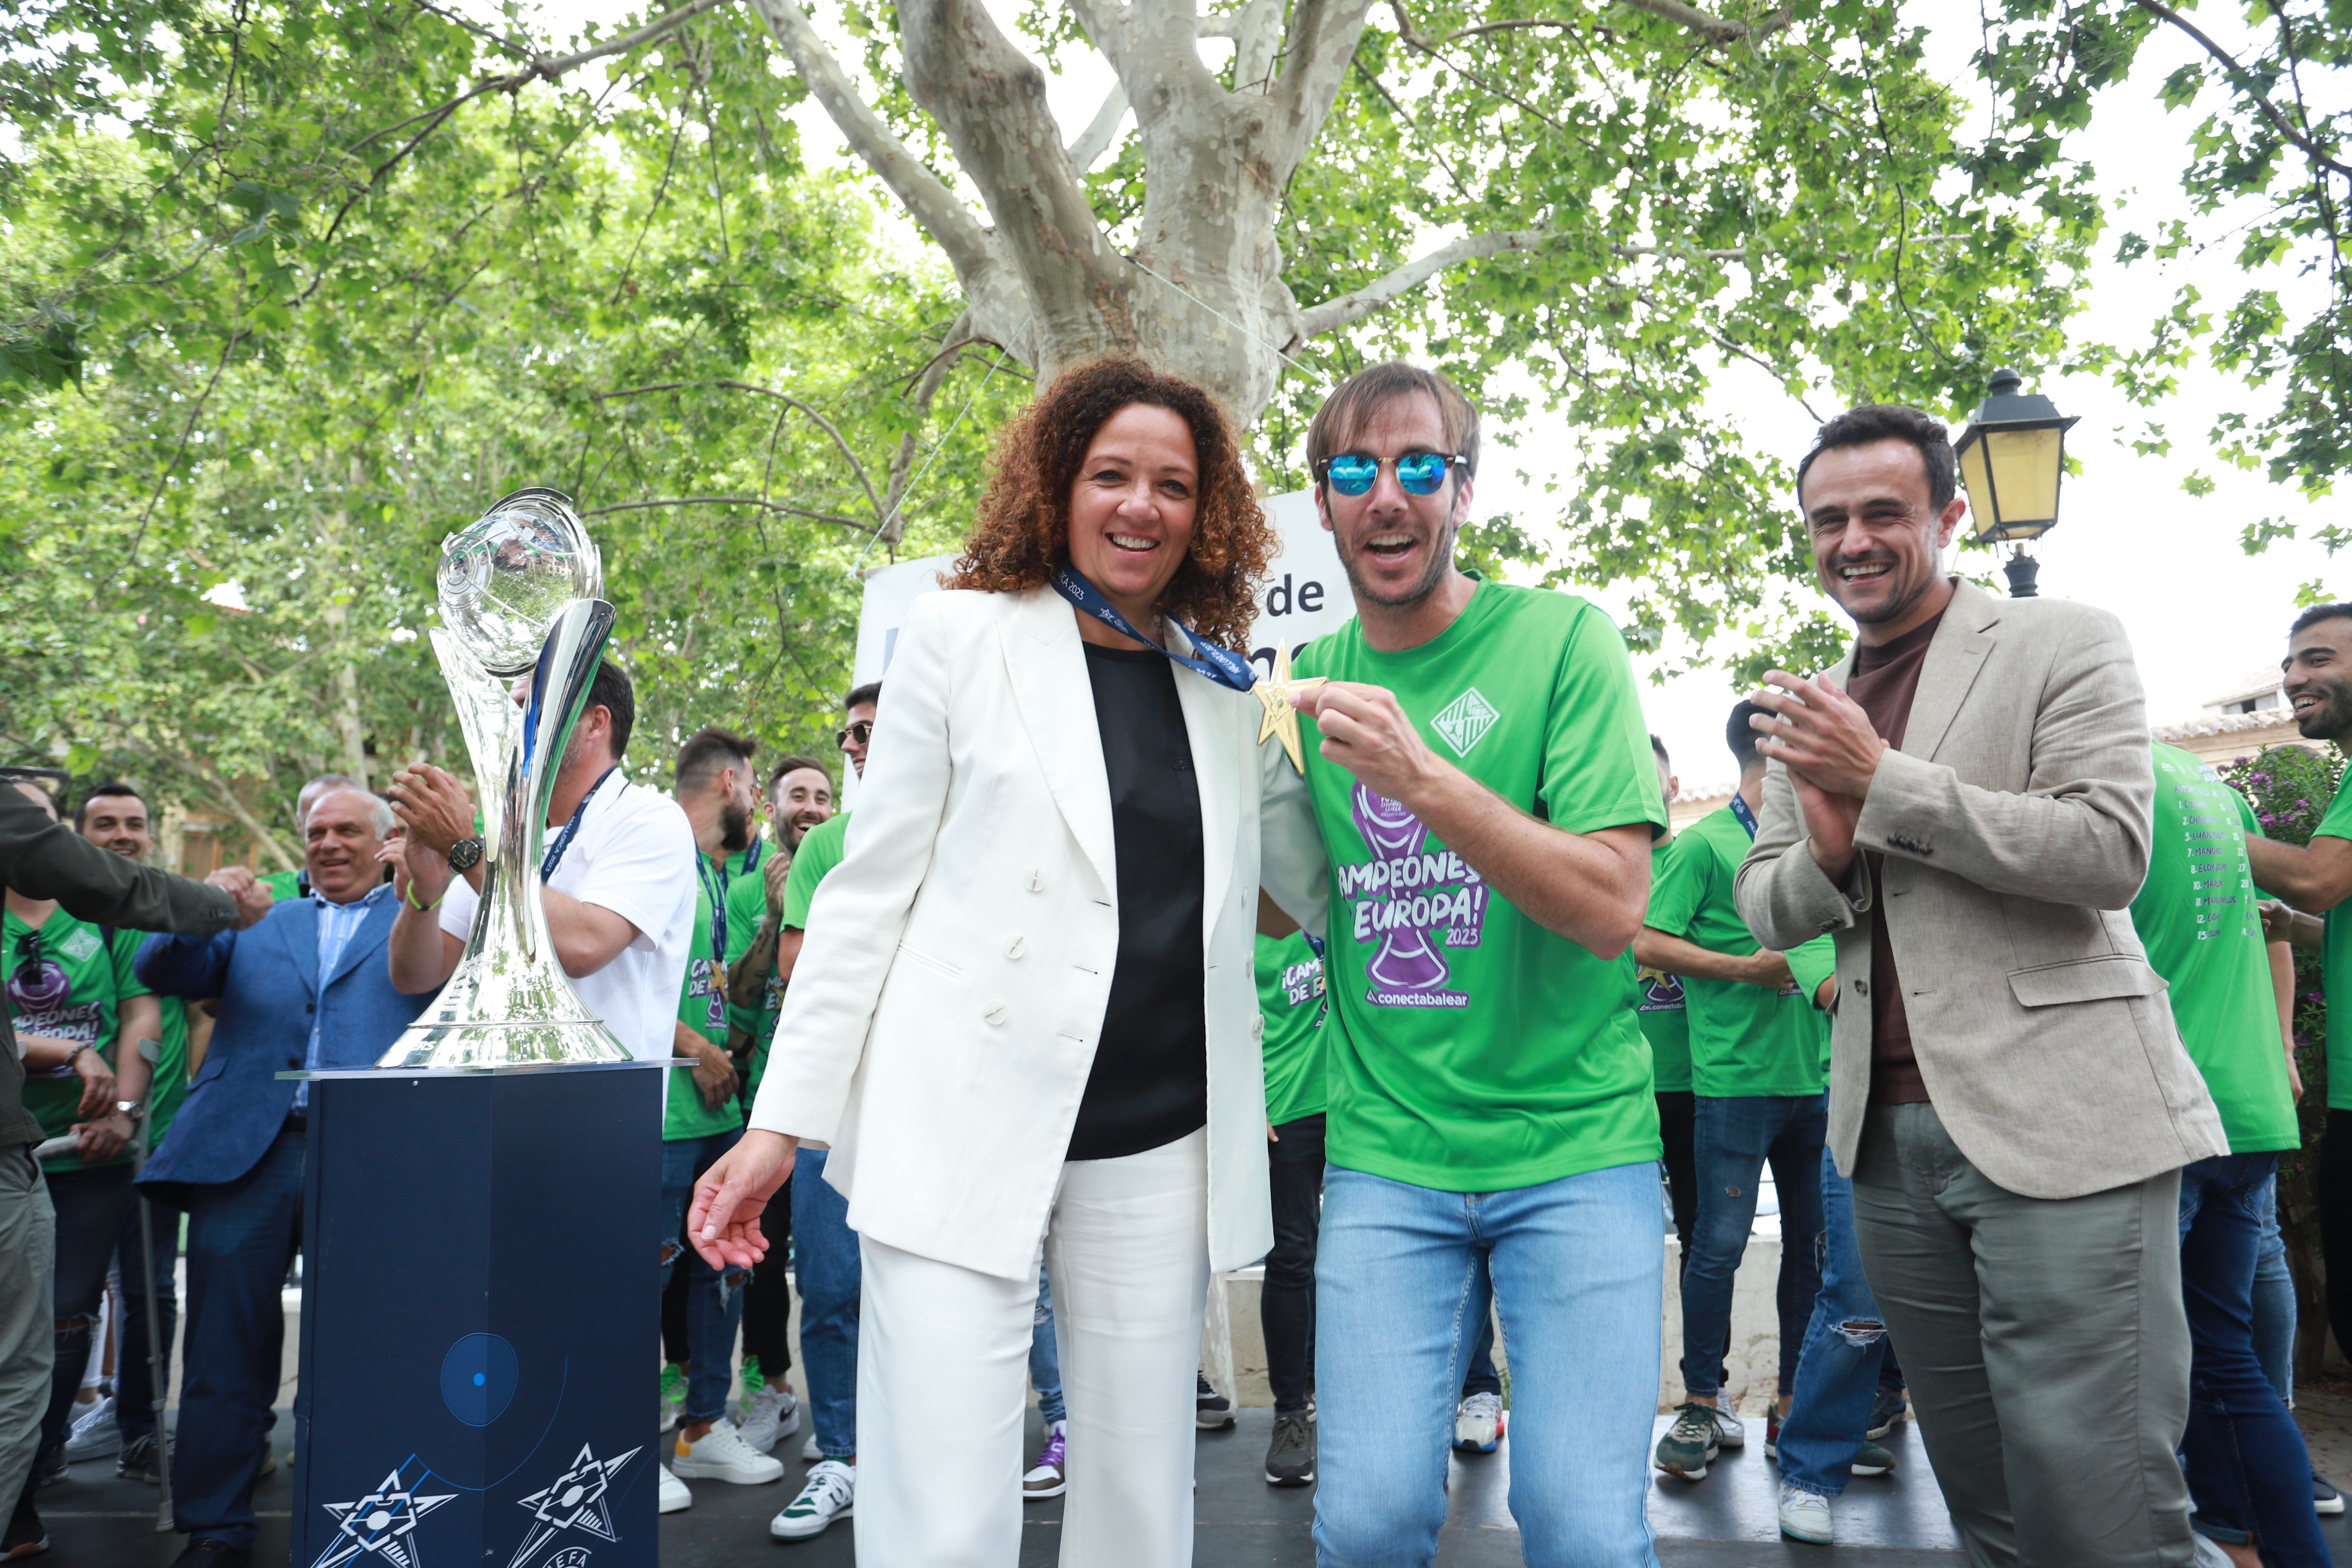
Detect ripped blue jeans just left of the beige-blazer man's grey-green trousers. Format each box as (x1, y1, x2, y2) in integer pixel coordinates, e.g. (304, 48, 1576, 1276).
(1778, 1150, 1886, 1498)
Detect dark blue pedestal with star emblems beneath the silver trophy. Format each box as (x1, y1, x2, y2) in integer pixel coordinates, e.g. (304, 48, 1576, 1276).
(292, 1063, 666, 1568)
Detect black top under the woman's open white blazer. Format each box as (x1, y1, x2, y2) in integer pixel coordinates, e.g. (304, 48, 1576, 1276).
(1070, 642, 1209, 1159)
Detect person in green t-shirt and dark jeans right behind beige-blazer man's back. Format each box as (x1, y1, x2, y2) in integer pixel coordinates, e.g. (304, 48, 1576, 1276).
(2131, 743, 2329, 1563)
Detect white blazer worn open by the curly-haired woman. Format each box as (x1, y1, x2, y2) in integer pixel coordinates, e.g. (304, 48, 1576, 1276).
(750, 588, 1272, 1279)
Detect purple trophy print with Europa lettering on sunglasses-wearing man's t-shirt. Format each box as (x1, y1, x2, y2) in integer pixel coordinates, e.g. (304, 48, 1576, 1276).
(1338, 785, 1487, 1006)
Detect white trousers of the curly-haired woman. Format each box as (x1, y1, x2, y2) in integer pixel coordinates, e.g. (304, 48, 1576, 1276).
(856, 1131, 1209, 1568)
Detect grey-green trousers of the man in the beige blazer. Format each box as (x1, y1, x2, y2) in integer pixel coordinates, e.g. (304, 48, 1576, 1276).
(1853, 1105, 2197, 1568)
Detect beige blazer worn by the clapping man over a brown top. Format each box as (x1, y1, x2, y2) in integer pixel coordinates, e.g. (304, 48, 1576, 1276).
(1736, 581, 2230, 1199)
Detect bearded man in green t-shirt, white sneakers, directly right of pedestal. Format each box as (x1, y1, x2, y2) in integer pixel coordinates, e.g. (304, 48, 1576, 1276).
(661, 729, 783, 1486)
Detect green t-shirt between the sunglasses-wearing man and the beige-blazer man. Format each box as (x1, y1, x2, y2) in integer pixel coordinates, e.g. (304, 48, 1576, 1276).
(1646, 806, 1834, 1100)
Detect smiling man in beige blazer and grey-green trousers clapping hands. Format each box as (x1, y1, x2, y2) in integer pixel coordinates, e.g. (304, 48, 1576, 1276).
(1736, 404, 2230, 1568)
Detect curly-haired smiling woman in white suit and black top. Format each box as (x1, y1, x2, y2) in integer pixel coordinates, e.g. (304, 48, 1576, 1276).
(689, 357, 1272, 1568)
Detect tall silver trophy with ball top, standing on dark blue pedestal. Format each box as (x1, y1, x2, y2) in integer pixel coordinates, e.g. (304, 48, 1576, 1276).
(376, 489, 630, 1067)
